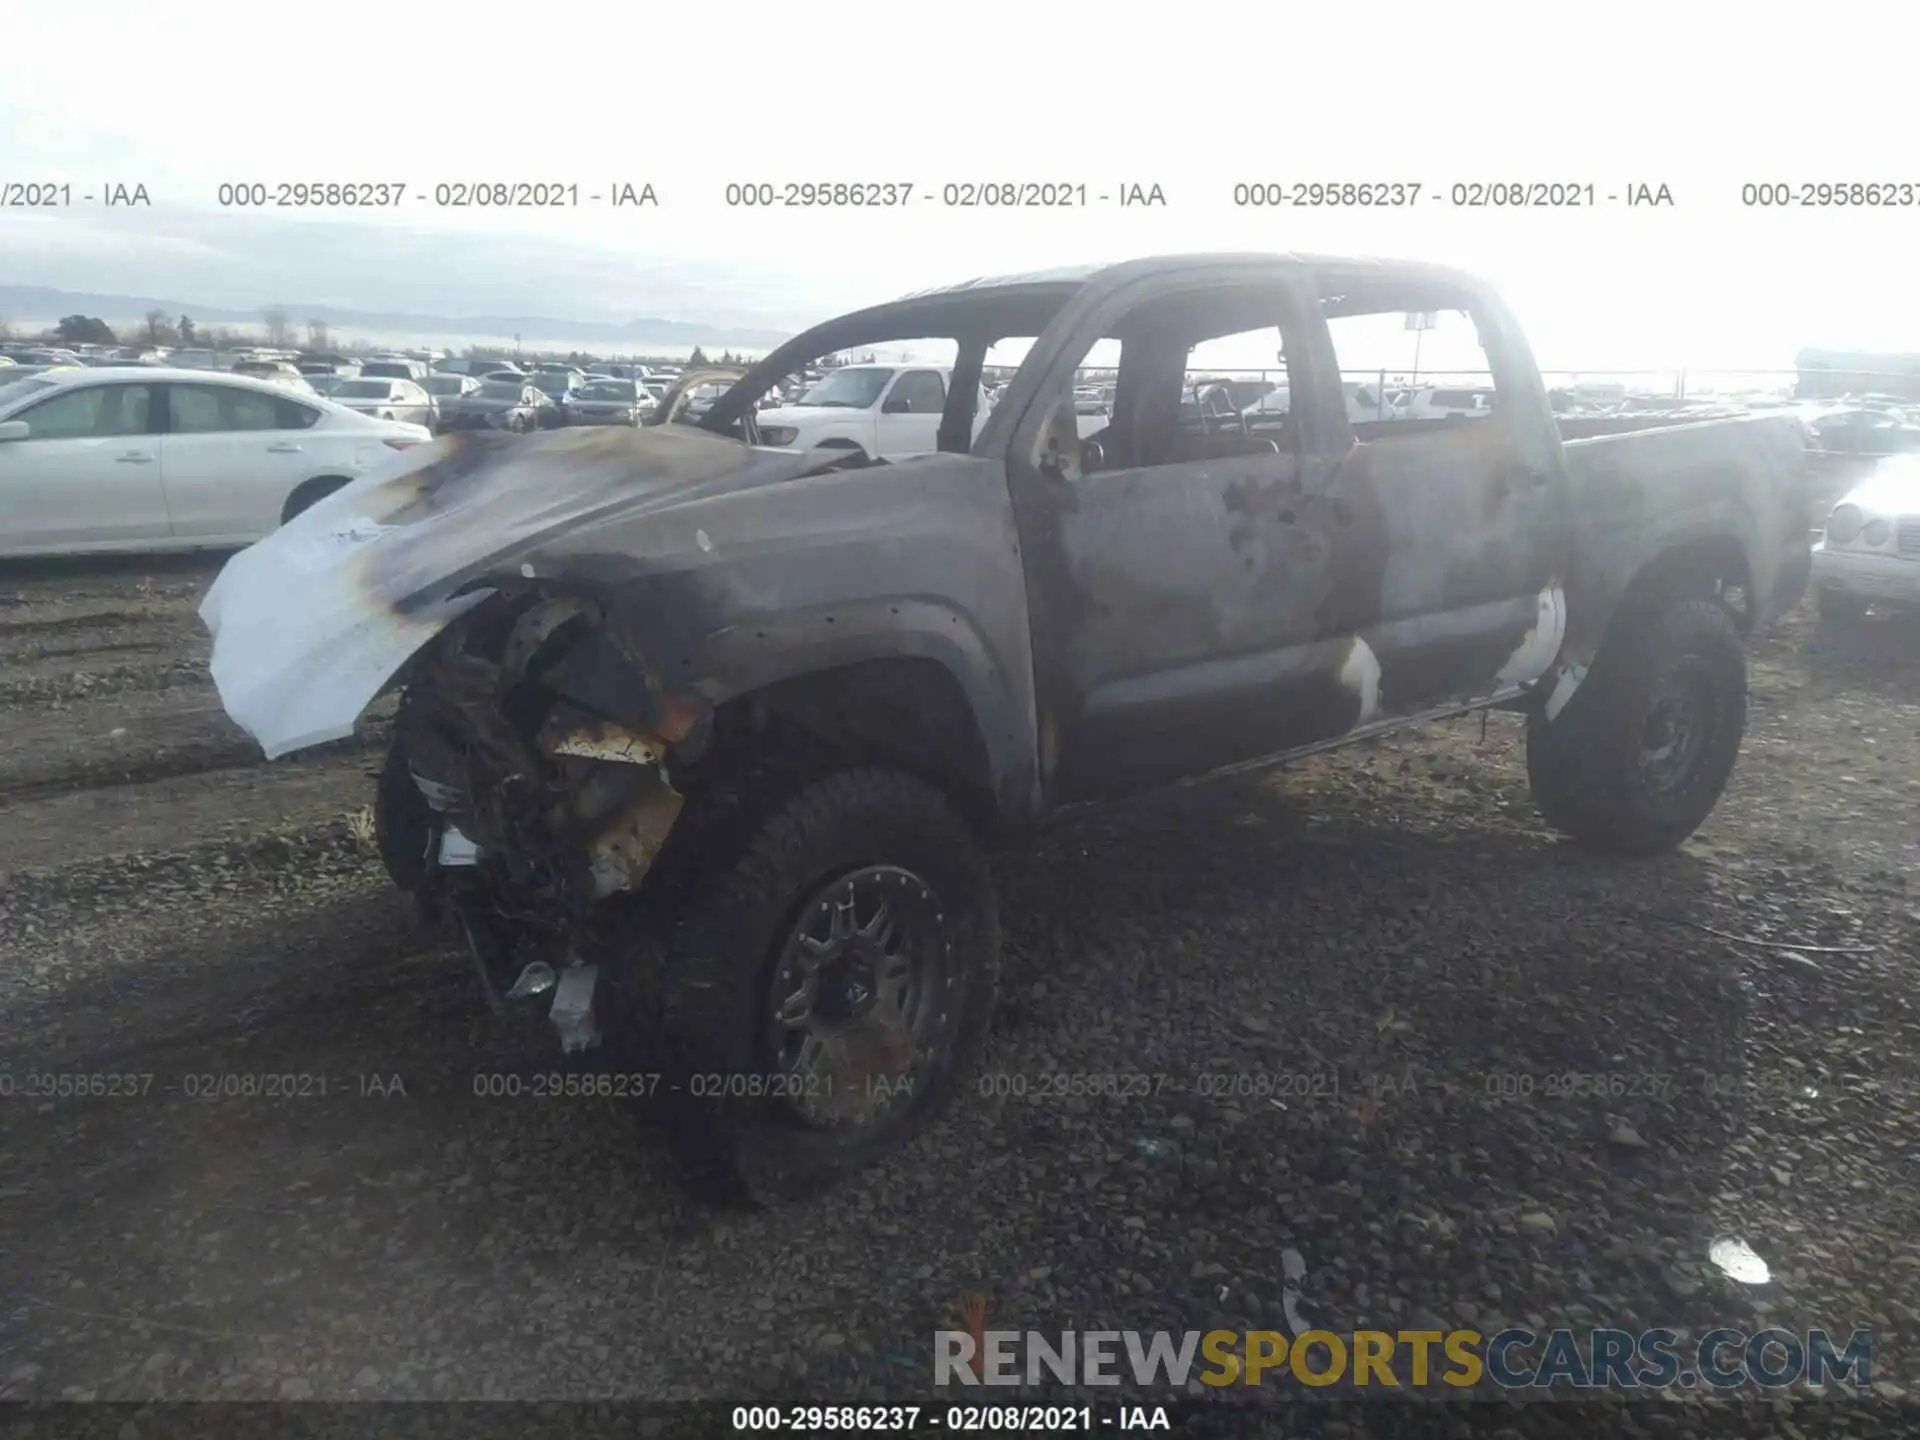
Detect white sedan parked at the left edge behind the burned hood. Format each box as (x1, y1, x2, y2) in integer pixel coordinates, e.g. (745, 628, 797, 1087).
(0, 367, 432, 557)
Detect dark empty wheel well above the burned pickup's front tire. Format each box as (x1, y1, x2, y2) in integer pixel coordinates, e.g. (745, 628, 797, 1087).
(699, 657, 998, 831)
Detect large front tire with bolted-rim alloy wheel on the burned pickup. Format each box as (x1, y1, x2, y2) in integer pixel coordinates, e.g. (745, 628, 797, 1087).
(662, 770, 1000, 1204)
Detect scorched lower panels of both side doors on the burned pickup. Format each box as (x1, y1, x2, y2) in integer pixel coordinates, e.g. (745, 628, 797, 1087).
(1029, 410, 1553, 803)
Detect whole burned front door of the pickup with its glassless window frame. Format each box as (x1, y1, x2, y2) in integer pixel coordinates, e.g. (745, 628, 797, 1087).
(1010, 267, 1377, 803)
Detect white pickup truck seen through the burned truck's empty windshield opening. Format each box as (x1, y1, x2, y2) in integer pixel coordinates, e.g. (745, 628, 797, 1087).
(755, 365, 991, 461)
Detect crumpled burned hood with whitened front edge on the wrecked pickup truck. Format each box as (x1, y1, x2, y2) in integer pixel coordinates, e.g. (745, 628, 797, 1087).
(200, 426, 848, 758)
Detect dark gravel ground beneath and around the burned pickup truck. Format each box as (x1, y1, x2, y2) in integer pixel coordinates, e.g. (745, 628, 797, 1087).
(0, 561, 1920, 1436)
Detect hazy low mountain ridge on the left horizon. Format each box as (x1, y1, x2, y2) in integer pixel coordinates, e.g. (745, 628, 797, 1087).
(0, 284, 787, 349)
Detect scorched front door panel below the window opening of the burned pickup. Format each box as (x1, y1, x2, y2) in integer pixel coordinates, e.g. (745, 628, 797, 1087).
(1054, 445, 1379, 803)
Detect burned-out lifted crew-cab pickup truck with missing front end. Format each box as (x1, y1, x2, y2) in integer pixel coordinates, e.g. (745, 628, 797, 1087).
(202, 255, 1809, 1196)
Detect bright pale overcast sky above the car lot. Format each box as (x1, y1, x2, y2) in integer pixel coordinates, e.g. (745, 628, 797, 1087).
(0, 0, 1920, 371)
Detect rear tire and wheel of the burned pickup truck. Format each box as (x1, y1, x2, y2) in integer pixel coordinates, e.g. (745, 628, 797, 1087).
(1526, 599, 1747, 856)
